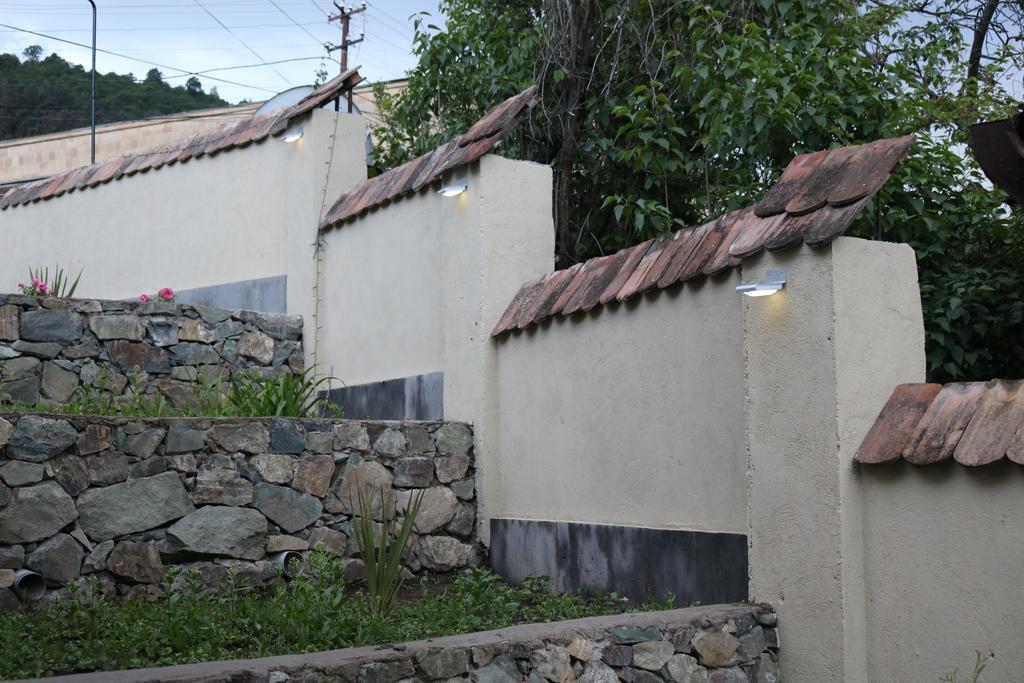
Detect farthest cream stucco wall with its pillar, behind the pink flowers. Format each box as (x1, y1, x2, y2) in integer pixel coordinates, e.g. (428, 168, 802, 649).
(0, 110, 366, 370)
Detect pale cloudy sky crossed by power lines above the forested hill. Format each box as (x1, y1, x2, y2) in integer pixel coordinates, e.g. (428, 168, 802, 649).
(0, 0, 439, 102)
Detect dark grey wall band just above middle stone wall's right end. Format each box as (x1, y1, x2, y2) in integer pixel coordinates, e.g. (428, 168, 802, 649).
(321, 373, 444, 420)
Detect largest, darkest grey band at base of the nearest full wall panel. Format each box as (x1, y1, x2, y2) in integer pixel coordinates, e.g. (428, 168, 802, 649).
(490, 518, 748, 607)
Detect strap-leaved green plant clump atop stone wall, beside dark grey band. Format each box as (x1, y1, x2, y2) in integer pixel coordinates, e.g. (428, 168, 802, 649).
(227, 368, 333, 418)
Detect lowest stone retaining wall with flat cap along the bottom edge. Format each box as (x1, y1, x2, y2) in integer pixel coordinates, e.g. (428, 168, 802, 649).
(28, 604, 782, 683)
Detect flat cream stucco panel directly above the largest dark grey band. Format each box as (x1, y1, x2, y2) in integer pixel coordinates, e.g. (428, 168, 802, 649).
(485, 271, 746, 532)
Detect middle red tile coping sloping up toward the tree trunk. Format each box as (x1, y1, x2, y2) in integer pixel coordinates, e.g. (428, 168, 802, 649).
(321, 86, 537, 230)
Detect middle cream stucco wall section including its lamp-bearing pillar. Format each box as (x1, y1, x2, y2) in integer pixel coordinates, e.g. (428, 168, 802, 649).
(319, 156, 554, 395)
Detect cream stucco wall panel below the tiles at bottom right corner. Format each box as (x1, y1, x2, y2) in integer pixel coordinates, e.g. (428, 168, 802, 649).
(860, 461, 1024, 683)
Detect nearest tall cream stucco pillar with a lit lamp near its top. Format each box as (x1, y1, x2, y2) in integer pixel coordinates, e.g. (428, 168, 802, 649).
(744, 238, 925, 683)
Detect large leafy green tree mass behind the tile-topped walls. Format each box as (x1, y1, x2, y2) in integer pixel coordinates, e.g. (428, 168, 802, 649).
(375, 0, 1024, 380)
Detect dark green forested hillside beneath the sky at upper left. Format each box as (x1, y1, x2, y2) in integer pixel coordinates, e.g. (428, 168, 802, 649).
(0, 45, 228, 140)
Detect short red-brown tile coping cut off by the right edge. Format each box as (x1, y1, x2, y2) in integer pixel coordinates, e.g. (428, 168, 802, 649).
(854, 380, 1024, 467)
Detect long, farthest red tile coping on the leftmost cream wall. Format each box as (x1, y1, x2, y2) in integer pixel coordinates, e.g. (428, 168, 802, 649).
(0, 69, 362, 209)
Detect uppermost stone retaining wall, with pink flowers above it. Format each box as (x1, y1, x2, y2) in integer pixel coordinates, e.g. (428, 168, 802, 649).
(0, 294, 303, 409)
